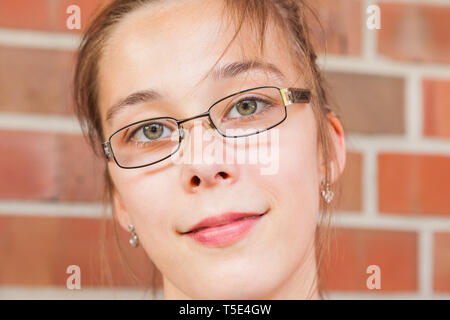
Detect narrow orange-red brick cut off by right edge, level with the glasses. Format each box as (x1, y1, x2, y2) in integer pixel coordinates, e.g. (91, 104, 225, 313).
(423, 79, 450, 138)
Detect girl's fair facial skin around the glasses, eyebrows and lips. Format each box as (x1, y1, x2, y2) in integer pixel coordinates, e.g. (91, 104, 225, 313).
(99, 0, 342, 299)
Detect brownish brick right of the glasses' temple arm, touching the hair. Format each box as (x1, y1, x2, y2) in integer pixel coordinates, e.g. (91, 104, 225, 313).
(325, 72, 405, 134)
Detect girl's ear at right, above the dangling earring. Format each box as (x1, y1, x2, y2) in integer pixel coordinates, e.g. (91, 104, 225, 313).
(327, 112, 346, 184)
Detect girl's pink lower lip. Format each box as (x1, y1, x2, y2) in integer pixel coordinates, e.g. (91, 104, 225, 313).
(188, 216, 263, 247)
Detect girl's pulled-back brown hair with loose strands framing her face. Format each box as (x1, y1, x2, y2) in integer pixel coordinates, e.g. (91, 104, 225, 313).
(74, 0, 340, 297)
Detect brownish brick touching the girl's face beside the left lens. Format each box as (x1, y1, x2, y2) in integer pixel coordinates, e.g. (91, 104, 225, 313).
(60, 135, 105, 201)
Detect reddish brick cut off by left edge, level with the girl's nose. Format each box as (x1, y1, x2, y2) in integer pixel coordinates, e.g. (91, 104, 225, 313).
(0, 131, 58, 200)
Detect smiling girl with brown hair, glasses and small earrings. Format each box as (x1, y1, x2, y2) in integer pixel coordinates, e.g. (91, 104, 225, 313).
(74, 0, 345, 299)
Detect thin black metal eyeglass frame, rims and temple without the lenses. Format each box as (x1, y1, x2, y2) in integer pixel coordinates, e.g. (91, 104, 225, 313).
(102, 86, 311, 169)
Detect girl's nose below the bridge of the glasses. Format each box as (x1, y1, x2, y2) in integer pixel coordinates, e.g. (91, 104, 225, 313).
(181, 118, 239, 193)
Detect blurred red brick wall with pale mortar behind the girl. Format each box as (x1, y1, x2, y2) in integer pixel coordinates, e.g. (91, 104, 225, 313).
(0, 0, 450, 298)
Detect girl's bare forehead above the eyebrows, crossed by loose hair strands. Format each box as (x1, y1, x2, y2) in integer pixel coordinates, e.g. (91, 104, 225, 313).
(99, 0, 298, 120)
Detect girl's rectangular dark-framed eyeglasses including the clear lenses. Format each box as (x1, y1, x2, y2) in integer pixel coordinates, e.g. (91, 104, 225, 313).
(102, 86, 311, 169)
